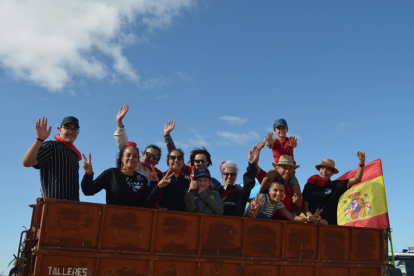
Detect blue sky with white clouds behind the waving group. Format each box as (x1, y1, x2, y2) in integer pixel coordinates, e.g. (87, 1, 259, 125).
(0, 0, 414, 274)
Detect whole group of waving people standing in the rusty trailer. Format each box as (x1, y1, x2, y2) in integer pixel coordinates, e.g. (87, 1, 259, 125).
(22, 105, 365, 225)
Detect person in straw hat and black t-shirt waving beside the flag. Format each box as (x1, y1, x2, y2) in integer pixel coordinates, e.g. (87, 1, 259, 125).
(303, 151, 365, 225)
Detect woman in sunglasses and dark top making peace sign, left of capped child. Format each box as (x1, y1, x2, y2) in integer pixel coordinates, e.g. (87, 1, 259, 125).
(150, 149, 191, 212)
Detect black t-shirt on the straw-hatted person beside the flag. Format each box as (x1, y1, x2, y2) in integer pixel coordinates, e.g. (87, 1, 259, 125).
(303, 180, 348, 225)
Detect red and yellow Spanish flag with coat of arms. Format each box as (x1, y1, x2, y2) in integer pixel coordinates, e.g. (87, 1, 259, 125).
(337, 159, 390, 229)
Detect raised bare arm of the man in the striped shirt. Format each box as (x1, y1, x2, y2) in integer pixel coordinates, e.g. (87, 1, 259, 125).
(22, 117, 52, 167)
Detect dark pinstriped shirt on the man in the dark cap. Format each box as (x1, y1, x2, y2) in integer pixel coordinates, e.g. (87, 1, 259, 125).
(33, 141, 79, 201)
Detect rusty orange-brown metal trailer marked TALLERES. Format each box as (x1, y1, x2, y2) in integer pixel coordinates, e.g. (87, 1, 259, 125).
(12, 198, 388, 276)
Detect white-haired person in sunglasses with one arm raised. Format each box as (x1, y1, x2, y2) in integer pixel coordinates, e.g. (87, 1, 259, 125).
(218, 146, 260, 217)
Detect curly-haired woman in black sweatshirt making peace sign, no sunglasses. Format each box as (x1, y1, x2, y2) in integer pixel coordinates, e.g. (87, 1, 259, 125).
(81, 142, 158, 207)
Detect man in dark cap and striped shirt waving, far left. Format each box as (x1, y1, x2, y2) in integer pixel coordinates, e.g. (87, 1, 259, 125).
(22, 116, 81, 201)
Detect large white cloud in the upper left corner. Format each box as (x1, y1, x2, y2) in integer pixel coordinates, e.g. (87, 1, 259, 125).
(0, 0, 195, 91)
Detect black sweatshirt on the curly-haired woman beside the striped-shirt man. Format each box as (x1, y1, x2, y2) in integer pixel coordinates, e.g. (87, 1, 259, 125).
(81, 168, 151, 207)
